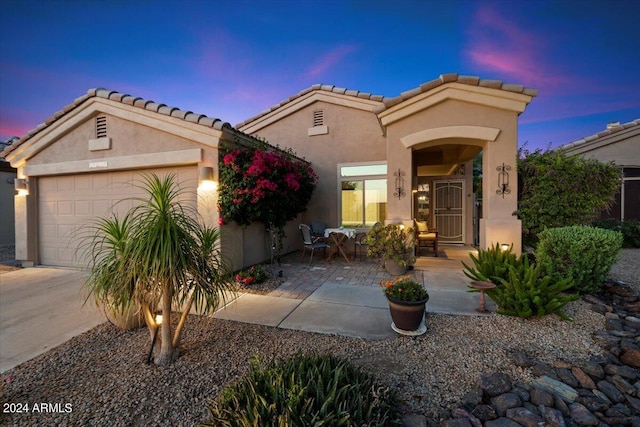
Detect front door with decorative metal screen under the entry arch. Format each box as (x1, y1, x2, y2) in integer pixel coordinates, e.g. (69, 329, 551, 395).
(433, 180, 465, 243)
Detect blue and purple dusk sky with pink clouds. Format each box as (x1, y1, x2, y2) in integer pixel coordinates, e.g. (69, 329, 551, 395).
(0, 0, 640, 149)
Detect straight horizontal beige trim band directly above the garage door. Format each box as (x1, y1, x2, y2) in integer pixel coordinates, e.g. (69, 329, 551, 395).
(24, 148, 202, 176)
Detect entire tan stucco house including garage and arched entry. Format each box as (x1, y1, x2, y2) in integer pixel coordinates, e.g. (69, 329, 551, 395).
(2, 74, 537, 268)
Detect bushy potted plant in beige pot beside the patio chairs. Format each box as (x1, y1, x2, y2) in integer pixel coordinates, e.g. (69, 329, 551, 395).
(367, 224, 416, 276)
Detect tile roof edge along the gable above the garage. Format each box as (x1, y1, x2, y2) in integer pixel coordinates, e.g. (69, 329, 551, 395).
(2, 88, 235, 156)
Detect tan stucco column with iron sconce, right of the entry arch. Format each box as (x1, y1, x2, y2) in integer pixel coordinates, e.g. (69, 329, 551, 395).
(480, 132, 522, 255)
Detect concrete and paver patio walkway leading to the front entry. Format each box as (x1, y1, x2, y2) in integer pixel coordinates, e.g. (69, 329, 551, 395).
(214, 246, 495, 339)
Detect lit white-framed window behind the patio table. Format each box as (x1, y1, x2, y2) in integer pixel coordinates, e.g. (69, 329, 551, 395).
(338, 163, 387, 228)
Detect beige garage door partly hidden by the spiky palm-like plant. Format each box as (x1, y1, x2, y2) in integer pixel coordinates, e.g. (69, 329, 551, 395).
(38, 166, 197, 267)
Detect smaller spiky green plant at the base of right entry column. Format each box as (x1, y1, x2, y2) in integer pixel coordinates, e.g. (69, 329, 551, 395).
(462, 243, 522, 285)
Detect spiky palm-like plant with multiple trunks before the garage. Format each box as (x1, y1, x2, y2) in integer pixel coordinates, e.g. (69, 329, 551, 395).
(86, 174, 234, 365)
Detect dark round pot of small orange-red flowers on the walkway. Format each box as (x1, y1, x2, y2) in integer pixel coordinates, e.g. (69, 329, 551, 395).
(380, 275, 429, 335)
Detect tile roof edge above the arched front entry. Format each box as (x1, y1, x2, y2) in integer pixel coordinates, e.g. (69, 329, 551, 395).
(374, 73, 538, 114)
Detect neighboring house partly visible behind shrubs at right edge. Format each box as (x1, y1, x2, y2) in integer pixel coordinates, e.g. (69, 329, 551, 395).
(559, 119, 640, 221)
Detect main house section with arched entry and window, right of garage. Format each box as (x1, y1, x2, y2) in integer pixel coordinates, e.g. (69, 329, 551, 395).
(236, 74, 537, 251)
